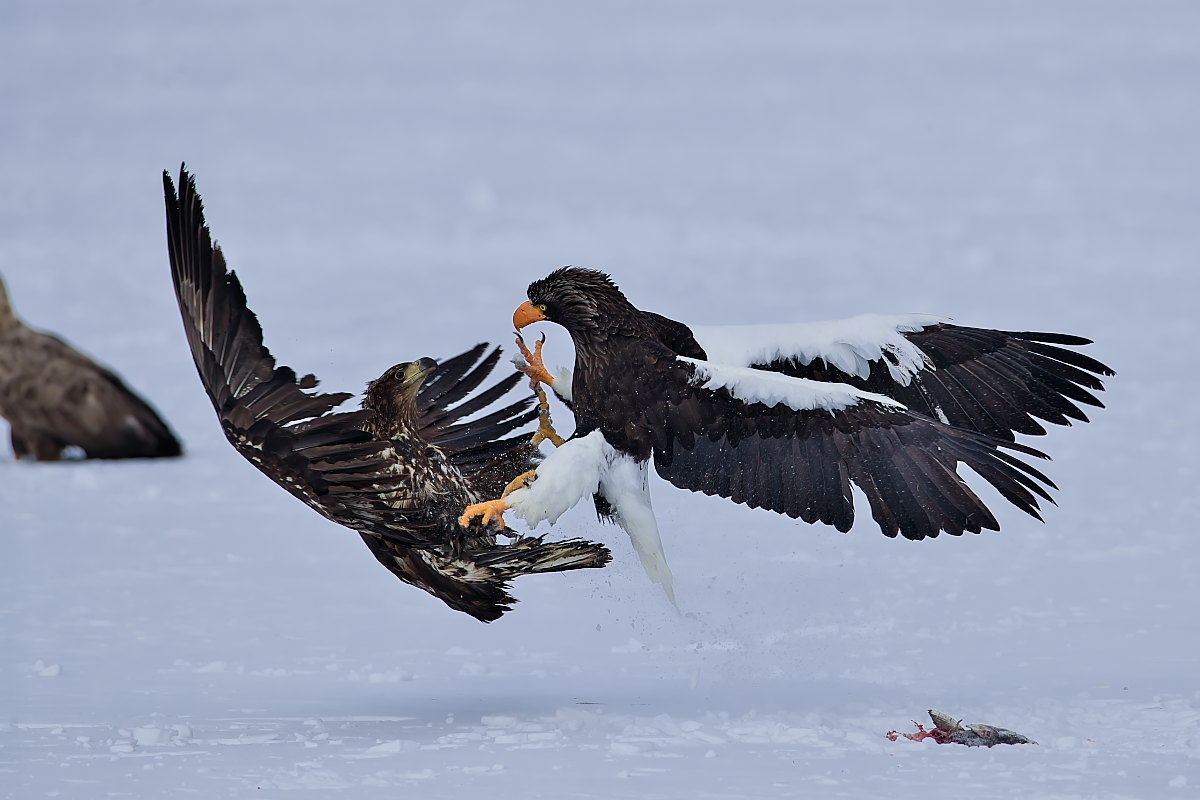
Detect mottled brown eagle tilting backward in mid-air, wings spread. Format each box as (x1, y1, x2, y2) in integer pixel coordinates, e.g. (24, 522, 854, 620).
(163, 170, 610, 621)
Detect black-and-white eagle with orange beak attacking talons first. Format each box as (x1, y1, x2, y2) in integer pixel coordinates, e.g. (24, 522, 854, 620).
(463, 267, 1112, 594)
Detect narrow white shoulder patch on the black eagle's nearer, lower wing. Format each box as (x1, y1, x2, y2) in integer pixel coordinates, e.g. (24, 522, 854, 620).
(676, 356, 904, 411)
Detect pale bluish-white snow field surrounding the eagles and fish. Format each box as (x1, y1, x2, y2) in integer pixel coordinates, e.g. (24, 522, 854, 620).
(0, 0, 1200, 800)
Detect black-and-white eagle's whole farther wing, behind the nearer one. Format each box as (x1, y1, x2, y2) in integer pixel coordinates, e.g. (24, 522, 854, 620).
(683, 314, 1114, 441)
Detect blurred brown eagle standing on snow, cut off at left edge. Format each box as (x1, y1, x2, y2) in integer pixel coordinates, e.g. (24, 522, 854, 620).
(0, 279, 182, 461)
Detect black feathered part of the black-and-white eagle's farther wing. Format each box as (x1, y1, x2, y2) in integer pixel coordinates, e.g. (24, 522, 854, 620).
(720, 323, 1115, 441)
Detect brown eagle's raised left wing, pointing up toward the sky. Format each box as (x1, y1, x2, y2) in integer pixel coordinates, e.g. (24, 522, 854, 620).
(163, 165, 438, 547)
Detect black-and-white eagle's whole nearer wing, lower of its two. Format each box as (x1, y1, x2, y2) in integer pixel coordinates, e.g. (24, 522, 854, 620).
(626, 347, 1054, 539)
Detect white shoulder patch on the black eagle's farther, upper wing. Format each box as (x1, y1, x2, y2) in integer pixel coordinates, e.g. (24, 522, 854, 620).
(692, 314, 948, 386)
